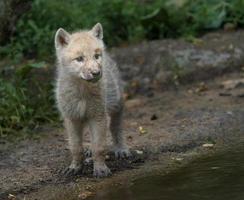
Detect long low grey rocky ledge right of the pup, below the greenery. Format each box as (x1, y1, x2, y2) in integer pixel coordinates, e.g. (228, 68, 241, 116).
(111, 30, 244, 94)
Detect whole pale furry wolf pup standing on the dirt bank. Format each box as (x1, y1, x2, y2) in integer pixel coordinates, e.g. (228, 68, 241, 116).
(55, 23, 130, 177)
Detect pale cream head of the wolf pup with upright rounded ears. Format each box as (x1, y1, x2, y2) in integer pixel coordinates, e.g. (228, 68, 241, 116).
(55, 23, 104, 82)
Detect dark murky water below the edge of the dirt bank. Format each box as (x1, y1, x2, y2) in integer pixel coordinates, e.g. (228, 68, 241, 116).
(91, 144, 244, 200)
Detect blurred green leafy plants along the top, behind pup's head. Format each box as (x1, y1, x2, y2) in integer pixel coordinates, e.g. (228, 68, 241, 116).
(1, 0, 244, 58)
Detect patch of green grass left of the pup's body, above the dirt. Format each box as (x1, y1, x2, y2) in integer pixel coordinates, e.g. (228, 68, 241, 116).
(0, 63, 58, 138)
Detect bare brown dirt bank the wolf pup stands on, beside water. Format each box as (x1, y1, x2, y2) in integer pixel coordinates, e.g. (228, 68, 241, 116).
(0, 72, 244, 199)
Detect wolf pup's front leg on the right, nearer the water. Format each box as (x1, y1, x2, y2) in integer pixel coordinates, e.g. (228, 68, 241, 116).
(89, 115, 111, 178)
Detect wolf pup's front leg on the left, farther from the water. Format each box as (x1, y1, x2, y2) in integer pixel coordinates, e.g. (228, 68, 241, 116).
(64, 119, 84, 175)
